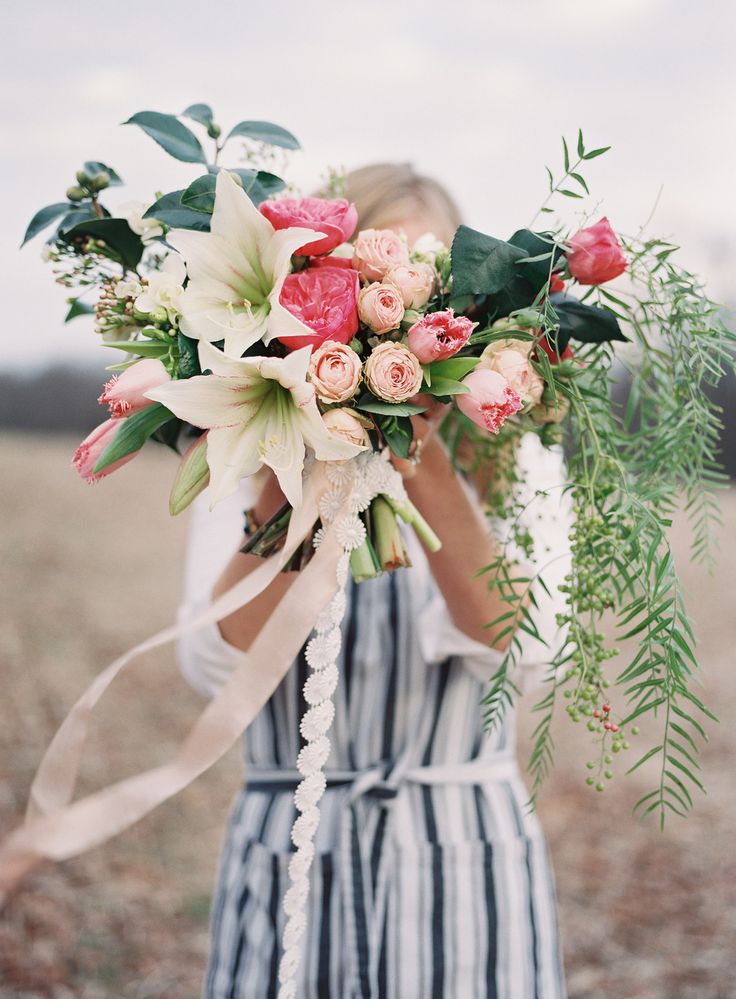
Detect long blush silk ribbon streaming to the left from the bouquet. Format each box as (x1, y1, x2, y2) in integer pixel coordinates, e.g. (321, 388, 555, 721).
(0, 463, 350, 904)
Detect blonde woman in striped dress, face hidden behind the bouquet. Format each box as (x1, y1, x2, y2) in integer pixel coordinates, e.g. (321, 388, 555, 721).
(180, 165, 567, 999)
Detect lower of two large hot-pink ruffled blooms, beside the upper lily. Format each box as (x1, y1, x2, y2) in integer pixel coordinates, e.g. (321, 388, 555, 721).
(277, 267, 360, 350)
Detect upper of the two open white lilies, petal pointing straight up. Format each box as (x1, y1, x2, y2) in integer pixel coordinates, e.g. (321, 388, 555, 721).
(172, 170, 321, 357)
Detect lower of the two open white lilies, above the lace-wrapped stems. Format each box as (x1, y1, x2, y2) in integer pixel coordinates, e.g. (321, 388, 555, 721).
(146, 341, 365, 507)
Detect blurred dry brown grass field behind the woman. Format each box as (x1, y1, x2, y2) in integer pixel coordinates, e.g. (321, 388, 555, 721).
(0, 435, 736, 999)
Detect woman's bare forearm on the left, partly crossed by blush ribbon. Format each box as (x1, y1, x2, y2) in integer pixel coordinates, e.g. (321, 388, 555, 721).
(212, 471, 297, 652)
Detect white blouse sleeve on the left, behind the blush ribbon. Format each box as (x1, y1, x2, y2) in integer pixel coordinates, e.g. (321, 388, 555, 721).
(177, 479, 253, 697)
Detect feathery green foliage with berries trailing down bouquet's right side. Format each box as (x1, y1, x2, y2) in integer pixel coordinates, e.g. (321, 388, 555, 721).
(454, 136, 736, 825)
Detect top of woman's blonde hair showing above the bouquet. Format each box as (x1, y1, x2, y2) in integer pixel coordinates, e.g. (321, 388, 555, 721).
(345, 163, 462, 244)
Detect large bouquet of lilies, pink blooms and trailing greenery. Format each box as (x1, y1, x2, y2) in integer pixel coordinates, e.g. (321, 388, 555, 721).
(14, 104, 734, 876)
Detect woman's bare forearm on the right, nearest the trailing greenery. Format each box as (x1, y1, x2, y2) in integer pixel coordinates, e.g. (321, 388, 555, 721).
(404, 420, 528, 652)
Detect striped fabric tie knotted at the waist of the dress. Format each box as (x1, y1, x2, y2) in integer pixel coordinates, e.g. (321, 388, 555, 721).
(246, 752, 520, 999)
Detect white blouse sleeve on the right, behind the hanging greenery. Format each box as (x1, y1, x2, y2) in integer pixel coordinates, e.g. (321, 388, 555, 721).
(420, 433, 572, 690)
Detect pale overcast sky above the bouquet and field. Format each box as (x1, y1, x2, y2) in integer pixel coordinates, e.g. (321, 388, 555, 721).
(0, 0, 736, 368)
